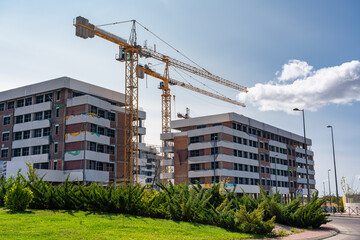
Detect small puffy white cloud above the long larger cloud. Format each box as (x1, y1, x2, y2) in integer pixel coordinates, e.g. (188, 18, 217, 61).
(277, 59, 313, 82)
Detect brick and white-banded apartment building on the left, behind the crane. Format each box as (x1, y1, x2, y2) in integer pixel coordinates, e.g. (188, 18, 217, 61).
(0, 77, 159, 184)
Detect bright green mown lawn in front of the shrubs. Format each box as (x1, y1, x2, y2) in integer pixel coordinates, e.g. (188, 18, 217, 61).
(0, 208, 262, 240)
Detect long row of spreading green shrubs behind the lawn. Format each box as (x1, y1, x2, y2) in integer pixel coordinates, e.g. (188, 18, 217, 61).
(0, 166, 329, 239)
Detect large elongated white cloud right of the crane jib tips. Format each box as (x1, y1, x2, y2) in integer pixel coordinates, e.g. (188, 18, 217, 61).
(238, 60, 360, 113)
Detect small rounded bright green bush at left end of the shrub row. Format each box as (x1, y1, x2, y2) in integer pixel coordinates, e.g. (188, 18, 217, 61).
(5, 177, 33, 212)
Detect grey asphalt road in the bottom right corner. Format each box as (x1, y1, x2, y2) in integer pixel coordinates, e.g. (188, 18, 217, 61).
(327, 217, 360, 240)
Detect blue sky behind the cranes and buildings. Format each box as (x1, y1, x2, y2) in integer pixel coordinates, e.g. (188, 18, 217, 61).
(0, 0, 360, 193)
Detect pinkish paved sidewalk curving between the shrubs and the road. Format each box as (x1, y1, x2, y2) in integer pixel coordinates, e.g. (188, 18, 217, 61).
(275, 224, 339, 240)
